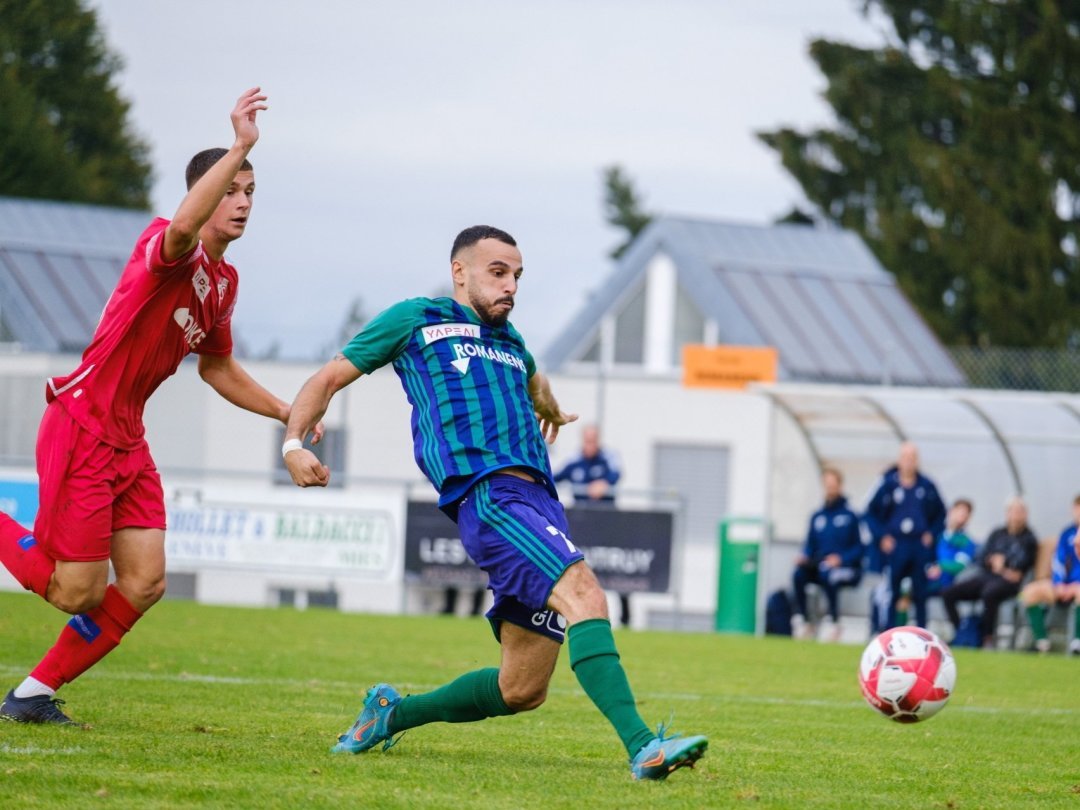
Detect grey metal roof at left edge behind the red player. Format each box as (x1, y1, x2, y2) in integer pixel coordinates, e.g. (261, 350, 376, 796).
(0, 197, 150, 353)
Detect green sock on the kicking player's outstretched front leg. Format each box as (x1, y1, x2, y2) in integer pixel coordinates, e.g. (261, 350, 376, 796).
(566, 619, 656, 757)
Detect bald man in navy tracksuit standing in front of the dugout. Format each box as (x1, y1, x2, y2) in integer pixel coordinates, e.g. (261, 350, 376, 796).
(866, 442, 945, 630)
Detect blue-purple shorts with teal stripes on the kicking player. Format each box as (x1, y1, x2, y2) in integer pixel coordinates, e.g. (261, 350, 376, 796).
(458, 474, 584, 644)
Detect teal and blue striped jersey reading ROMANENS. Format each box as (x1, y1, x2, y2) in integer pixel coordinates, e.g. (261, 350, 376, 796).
(342, 298, 558, 518)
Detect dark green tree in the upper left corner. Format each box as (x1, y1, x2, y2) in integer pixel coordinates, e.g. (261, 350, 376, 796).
(0, 0, 151, 208)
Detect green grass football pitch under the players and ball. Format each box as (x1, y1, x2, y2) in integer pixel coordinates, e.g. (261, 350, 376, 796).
(0, 594, 1080, 810)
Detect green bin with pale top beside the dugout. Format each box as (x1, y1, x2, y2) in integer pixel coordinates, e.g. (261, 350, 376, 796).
(716, 517, 766, 633)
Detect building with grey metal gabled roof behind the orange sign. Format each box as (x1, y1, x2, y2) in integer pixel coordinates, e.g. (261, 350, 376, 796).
(544, 217, 966, 386)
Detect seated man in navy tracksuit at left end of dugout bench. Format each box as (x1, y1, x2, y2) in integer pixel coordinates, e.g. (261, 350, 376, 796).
(792, 468, 863, 642)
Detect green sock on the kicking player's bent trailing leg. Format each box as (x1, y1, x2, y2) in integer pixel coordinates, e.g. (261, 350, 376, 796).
(390, 667, 513, 734)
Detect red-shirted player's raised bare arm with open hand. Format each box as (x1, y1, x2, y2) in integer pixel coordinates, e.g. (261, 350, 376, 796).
(161, 87, 267, 261)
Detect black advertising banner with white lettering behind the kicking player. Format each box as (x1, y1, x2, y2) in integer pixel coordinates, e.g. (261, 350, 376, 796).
(405, 501, 674, 593)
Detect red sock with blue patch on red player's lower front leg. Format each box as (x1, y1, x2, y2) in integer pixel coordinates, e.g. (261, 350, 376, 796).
(30, 585, 143, 689)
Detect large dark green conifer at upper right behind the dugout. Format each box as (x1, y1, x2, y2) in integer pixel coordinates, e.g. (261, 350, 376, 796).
(759, 0, 1080, 347)
